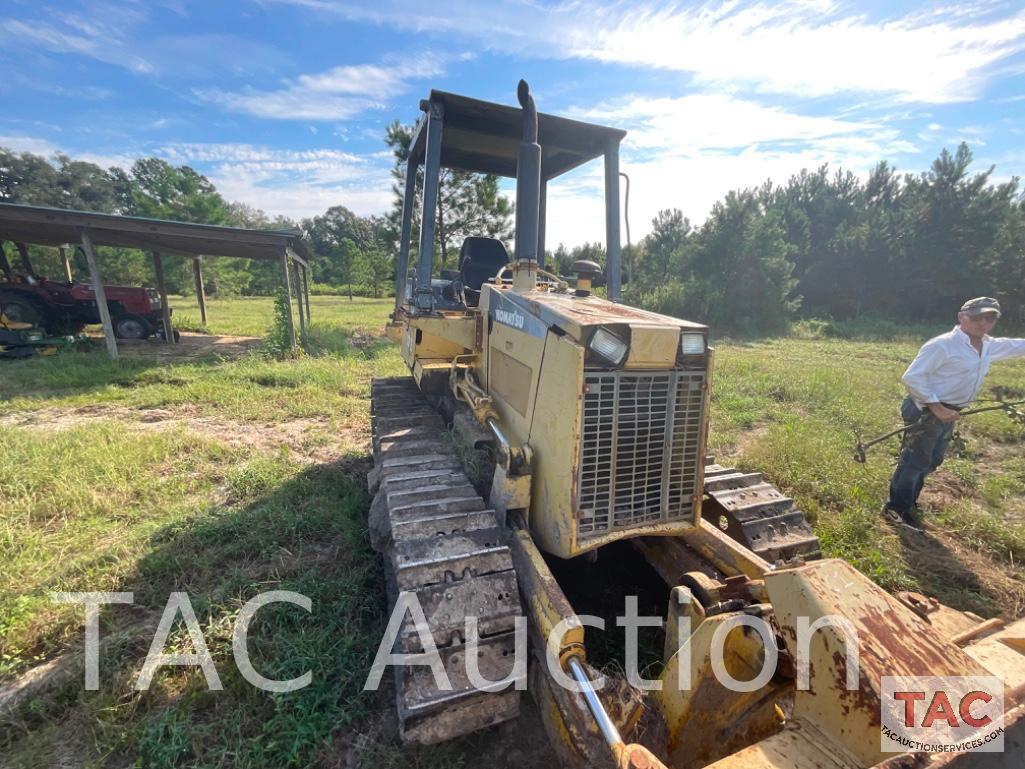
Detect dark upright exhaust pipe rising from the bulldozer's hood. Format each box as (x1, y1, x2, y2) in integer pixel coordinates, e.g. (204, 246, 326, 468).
(513, 80, 541, 291)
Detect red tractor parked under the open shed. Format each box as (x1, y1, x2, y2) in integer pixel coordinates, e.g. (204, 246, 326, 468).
(0, 244, 168, 339)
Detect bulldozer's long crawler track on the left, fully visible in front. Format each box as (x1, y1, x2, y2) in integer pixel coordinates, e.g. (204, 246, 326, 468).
(368, 376, 523, 744)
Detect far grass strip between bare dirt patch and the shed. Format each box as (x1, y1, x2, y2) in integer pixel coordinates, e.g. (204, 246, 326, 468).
(0, 296, 403, 421)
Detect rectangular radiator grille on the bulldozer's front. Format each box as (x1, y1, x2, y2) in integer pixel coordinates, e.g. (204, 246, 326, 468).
(577, 370, 704, 537)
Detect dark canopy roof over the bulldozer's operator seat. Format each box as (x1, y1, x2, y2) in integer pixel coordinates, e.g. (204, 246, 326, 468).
(410, 90, 626, 179)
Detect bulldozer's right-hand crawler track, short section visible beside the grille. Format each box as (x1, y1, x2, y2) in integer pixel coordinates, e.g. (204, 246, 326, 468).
(701, 458, 822, 563)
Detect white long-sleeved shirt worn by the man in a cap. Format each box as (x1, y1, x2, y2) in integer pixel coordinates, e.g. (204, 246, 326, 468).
(901, 326, 1025, 408)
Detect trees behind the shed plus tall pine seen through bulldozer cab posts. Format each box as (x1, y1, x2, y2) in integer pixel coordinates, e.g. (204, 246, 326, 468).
(0, 121, 513, 297)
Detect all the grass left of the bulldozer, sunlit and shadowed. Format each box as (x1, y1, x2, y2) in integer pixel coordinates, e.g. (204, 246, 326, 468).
(0, 297, 412, 767)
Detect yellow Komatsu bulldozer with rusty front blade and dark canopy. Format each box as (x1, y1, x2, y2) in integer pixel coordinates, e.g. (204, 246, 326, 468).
(368, 81, 1025, 769)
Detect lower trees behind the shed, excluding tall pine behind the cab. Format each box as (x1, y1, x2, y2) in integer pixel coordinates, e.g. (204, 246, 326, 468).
(0, 148, 394, 296)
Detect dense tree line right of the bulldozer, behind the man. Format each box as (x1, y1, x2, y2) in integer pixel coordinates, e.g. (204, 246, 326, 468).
(624, 144, 1025, 333)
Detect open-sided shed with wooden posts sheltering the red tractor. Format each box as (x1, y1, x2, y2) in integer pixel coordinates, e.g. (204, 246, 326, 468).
(0, 203, 313, 358)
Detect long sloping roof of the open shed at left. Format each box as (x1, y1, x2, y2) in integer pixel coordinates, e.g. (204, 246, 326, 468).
(0, 203, 312, 265)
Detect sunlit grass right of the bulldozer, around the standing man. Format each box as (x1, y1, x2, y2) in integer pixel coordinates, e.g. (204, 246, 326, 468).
(709, 339, 1025, 594)
